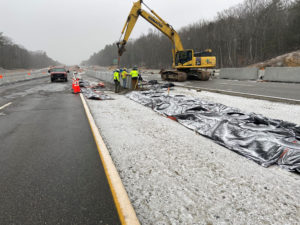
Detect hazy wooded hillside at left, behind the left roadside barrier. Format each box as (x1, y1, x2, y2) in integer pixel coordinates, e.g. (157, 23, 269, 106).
(0, 32, 58, 69)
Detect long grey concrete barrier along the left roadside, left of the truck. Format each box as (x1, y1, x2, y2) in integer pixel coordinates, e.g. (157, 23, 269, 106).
(0, 69, 49, 85)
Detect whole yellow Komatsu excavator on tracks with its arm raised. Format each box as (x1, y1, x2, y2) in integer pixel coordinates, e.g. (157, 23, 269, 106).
(117, 0, 216, 81)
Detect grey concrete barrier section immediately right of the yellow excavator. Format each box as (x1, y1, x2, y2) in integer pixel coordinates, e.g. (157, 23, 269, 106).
(219, 68, 258, 80)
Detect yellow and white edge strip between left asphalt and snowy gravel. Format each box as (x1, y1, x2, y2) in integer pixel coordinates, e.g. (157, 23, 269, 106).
(80, 94, 140, 225)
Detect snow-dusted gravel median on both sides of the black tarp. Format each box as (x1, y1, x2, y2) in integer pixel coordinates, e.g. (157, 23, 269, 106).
(88, 85, 300, 224)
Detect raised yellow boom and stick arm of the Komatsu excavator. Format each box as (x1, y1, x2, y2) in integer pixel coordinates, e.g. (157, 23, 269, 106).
(117, 0, 184, 56)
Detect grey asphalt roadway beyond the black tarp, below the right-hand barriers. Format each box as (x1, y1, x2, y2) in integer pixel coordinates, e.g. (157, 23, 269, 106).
(143, 73, 300, 100)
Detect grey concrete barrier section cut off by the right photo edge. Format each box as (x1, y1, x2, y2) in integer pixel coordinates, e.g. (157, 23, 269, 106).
(263, 67, 300, 83)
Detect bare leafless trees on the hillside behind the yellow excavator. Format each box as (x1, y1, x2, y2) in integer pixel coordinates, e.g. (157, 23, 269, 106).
(82, 0, 300, 68)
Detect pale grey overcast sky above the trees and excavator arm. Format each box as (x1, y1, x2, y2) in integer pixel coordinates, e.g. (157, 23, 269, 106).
(0, 0, 243, 65)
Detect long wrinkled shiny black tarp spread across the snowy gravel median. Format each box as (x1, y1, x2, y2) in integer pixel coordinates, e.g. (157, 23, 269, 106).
(127, 90, 300, 173)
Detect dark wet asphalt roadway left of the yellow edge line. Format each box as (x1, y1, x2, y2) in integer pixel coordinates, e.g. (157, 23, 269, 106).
(0, 79, 120, 225)
